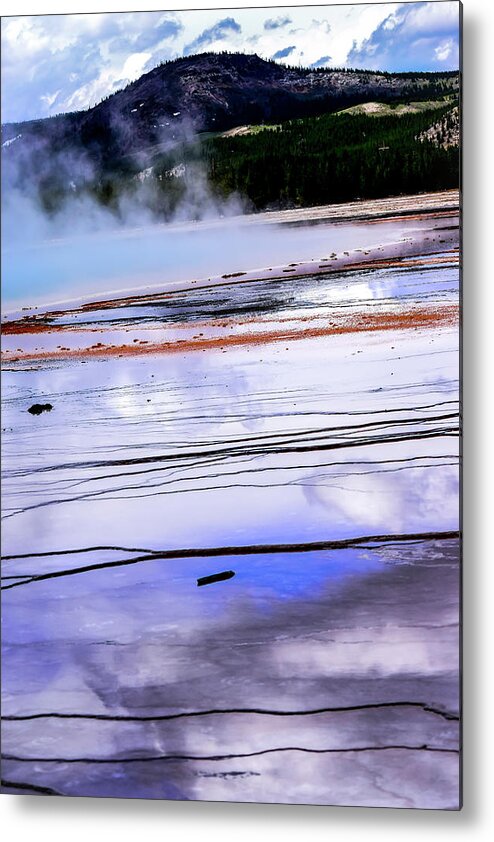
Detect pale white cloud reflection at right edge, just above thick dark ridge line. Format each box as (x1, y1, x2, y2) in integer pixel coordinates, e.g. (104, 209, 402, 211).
(302, 460, 459, 534)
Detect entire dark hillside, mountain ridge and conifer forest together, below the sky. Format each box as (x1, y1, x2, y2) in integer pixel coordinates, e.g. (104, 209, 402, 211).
(2, 53, 460, 219)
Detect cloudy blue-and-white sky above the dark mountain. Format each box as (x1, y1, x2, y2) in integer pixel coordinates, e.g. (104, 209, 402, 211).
(1, 0, 459, 123)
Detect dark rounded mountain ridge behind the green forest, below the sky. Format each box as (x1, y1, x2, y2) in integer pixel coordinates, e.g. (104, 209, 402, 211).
(2, 53, 459, 186)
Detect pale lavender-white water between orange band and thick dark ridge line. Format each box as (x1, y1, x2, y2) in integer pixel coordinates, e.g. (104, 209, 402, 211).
(3, 318, 458, 552)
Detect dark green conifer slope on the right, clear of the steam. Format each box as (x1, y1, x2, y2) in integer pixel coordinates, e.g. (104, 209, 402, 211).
(197, 104, 459, 208)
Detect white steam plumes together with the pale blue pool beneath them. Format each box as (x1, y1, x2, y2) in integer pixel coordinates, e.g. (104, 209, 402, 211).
(2, 108, 424, 314)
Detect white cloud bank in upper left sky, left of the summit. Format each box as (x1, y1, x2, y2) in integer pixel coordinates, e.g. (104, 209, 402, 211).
(2, 12, 182, 122)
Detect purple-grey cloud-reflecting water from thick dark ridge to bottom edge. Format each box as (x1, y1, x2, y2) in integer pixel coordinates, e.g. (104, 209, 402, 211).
(3, 541, 457, 806)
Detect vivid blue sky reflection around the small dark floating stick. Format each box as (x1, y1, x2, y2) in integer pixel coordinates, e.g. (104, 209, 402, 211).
(4, 549, 386, 645)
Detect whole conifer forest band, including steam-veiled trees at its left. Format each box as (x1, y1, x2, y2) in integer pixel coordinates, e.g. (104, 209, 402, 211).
(38, 99, 459, 220)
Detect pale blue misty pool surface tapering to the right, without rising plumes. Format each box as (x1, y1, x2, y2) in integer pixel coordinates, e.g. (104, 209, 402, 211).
(2, 221, 432, 308)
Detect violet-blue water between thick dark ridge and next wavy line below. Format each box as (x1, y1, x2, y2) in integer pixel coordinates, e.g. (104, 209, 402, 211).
(3, 542, 457, 711)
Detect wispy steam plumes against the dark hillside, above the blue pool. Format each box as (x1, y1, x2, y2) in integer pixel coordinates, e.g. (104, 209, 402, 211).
(2, 114, 244, 240)
